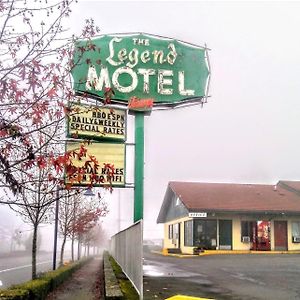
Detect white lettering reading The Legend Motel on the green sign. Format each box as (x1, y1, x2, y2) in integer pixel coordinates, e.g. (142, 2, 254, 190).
(85, 37, 195, 96)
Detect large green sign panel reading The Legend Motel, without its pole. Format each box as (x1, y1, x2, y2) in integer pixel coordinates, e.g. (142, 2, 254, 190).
(72, 34, 209, 105)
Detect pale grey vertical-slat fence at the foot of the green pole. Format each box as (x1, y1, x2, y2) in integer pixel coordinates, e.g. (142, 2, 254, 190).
(110, 221, 143, 299)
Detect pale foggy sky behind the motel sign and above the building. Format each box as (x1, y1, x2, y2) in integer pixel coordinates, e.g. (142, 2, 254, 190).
(2, 0, 300, 238)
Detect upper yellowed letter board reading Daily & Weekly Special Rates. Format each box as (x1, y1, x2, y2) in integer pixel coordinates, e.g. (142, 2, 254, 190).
(68, 104, 126, 142)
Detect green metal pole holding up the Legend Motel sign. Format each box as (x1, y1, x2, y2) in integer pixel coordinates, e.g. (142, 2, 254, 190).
(133, 112, 144, 222)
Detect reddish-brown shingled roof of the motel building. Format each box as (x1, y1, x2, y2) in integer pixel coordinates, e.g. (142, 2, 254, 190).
(169, 182, 300, 213)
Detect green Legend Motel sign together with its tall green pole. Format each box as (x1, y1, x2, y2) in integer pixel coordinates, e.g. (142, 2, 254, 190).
(71, 33, 210, 222)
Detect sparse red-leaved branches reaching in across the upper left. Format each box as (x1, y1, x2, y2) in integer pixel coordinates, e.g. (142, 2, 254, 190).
(0, 0, 104, 194)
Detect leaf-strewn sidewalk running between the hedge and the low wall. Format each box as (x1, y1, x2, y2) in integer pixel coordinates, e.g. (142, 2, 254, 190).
(46, 257, 104, 300)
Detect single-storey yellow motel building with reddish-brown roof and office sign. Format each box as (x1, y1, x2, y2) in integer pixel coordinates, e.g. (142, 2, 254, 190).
(157, 181, 300, 254)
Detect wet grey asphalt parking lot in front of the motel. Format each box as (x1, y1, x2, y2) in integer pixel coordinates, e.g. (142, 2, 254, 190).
(144, 253, 300, 300)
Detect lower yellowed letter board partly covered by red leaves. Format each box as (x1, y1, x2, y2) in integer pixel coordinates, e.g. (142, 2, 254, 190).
(66, 142, 125, 187)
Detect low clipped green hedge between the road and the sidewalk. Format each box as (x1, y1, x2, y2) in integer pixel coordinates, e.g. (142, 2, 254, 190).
(0, 258, 92, 300)
